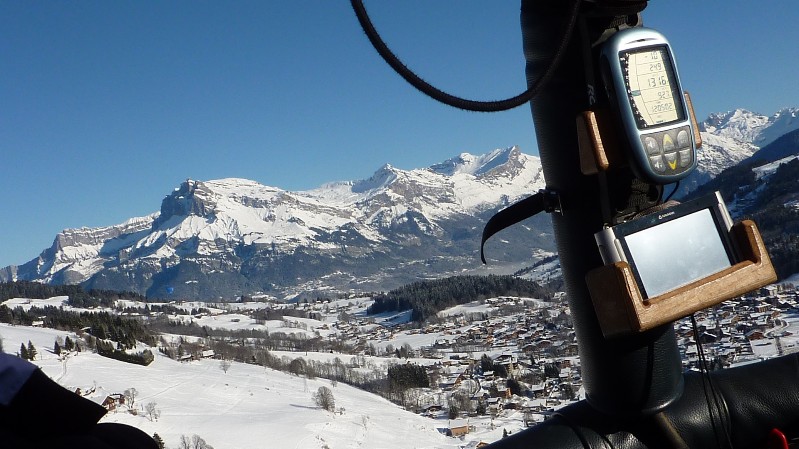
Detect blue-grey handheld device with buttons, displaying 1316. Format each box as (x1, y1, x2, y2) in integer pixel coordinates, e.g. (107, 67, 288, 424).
(600, 27, 696, 184)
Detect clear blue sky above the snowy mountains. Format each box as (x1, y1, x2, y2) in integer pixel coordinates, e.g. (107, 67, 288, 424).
(0, 0, 799, 267)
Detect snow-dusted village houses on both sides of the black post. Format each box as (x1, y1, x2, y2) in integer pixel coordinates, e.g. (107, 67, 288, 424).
(314, 286, 799, 424)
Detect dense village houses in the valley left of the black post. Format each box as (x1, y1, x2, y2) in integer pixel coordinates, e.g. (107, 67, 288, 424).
(336, 297, 582, 426)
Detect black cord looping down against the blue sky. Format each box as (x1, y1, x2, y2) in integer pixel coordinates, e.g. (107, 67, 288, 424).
(351, 0, 581, 112)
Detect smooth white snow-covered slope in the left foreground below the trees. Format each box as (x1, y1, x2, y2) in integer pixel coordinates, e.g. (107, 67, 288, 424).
(0, 324, 520, 449)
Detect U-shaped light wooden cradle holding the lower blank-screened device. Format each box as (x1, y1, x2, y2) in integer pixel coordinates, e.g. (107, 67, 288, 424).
(586, 220, 777, 338)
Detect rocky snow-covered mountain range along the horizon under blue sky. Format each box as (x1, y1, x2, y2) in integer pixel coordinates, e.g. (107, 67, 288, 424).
(0, 108, 799, 299)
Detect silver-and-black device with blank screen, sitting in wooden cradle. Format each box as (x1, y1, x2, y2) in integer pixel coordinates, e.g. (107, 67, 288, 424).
(594, 192, 737, 299)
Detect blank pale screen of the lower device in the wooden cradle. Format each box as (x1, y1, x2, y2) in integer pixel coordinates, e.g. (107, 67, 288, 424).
(625, 209, 731, 298)
